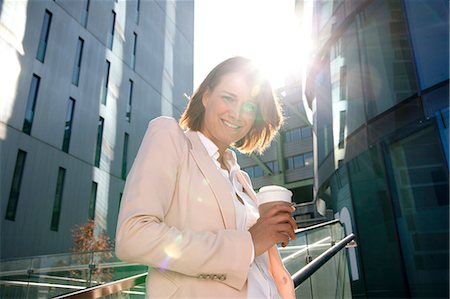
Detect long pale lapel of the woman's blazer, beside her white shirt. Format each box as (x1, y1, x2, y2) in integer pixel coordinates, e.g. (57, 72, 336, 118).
(186, 130, 236, 229)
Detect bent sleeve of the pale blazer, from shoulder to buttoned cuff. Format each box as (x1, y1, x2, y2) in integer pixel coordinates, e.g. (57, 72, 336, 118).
(115, 118, 252, 289)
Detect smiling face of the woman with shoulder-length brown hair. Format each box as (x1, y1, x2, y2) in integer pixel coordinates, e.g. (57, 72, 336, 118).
(201, 73, 257, 152)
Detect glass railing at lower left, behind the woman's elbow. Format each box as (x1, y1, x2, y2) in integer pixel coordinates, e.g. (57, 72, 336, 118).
(0, 251, 147, 298)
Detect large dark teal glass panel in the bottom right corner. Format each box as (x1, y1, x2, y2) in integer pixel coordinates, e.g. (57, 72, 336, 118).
(389, 126, 449, 298)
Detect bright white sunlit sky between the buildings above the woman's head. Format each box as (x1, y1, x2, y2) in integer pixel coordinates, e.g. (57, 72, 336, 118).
(194, 0, 310, 90)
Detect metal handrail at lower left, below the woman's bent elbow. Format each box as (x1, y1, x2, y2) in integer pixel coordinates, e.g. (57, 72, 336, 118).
(53, 272, 147, 299)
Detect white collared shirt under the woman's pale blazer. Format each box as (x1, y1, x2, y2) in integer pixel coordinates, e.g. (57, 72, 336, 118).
(197, 132, 281, 299)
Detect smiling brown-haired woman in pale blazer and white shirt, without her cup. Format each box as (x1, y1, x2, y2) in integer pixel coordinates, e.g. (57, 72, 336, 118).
(116, 57, 296, 298)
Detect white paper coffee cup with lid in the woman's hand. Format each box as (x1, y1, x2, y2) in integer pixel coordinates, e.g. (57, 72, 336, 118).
(256, 185, 292, 215)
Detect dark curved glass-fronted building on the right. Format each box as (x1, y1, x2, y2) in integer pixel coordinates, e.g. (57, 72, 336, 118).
(305, 0, 449, 298)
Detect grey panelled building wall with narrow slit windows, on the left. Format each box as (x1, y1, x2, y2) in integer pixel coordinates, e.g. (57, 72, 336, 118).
(0, 0, 194, 258)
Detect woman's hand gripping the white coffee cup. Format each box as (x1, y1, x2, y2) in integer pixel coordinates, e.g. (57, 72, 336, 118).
(248, 203, 297, 256)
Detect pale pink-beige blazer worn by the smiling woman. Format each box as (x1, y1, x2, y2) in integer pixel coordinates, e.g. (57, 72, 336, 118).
(116, 117, 293, 298)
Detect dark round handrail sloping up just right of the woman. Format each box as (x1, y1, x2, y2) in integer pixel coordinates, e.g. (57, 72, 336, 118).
(292, 234, 355, 288)
